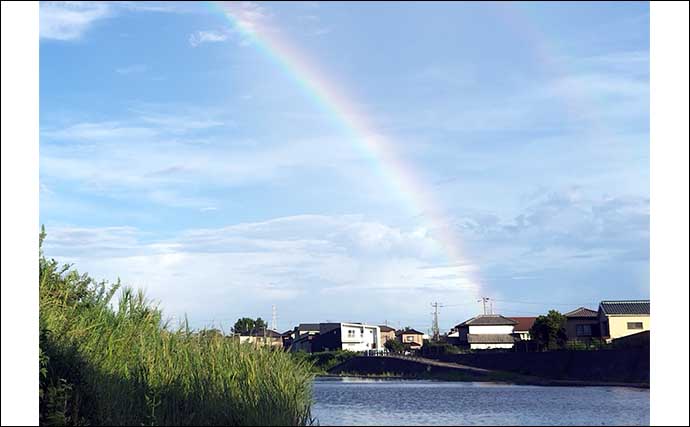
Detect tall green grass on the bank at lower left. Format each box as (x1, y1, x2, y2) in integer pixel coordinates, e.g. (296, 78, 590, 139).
(39, 234, 312, 425)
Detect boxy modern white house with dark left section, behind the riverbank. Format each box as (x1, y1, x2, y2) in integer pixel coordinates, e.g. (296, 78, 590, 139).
(290, 322, 383, 353)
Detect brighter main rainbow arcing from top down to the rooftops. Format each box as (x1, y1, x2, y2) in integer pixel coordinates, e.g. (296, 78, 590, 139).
(207, 2, 480, 296)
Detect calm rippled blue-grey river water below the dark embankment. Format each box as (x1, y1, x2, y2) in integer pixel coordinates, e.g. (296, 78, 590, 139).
(312, 378, 649, 425)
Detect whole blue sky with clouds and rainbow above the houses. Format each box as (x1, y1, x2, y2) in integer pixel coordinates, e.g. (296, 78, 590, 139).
(39, 2, 649, 331)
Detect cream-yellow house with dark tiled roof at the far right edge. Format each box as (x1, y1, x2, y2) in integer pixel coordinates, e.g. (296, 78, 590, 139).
(598, 300, 650, 342)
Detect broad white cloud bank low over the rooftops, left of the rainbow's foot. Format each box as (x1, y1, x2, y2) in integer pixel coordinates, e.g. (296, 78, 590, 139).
(45, 215, 476, 328)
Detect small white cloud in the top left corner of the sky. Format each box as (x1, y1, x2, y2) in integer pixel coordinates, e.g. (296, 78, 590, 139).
(39, 2, 112, 40)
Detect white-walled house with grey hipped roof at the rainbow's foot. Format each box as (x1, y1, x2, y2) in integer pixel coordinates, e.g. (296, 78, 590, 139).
(454, 314, 518, 350)
